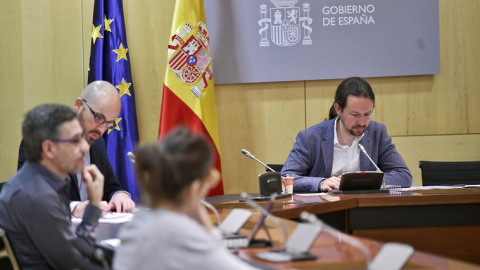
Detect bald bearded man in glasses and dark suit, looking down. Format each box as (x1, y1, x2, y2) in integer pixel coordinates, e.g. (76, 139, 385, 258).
(17, 81, 135, 217)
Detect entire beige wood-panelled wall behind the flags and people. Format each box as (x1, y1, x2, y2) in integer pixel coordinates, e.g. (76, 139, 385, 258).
(0, 0, 480, 193)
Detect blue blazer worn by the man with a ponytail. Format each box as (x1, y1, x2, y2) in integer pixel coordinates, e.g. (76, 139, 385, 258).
(282, 118, 413, 192)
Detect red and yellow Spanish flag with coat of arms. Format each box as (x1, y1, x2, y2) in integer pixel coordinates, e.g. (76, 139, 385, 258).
(158, 0, 223, 196)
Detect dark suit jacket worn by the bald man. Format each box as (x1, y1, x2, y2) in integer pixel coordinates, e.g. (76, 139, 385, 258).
(17, 137, 123, 202)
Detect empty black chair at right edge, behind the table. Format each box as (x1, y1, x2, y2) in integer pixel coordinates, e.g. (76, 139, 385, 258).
(419, 161, 480, 186)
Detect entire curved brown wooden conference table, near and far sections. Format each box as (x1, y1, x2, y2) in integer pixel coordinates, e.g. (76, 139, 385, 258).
(92, 188, 480, 270)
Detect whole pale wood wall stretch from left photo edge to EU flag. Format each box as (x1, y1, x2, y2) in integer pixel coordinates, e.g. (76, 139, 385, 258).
(0, 0, 83, 181)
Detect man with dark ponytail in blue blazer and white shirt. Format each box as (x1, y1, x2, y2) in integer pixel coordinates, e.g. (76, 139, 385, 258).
(282, 77, 412, 192)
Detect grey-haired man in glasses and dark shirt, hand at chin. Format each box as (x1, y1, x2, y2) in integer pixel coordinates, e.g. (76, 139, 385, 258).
(0, 104, 104, 269)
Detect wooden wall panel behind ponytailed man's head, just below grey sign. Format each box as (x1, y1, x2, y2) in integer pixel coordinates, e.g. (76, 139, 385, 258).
(306, 73, 470, 136)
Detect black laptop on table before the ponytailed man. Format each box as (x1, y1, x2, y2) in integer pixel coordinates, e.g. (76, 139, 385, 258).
(329, 171, 389, 194)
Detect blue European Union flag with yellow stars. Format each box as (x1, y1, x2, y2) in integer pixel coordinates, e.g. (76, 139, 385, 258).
(88, 0, 139, 202)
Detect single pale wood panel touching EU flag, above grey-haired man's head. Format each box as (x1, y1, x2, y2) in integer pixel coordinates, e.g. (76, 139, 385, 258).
(22, 0, 83, 108)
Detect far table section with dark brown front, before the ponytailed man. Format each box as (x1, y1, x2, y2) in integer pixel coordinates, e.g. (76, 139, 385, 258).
(208, 187, 480, 264)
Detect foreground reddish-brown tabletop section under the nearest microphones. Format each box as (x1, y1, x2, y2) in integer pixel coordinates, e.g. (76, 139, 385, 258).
(227, 213, 480, 270)
